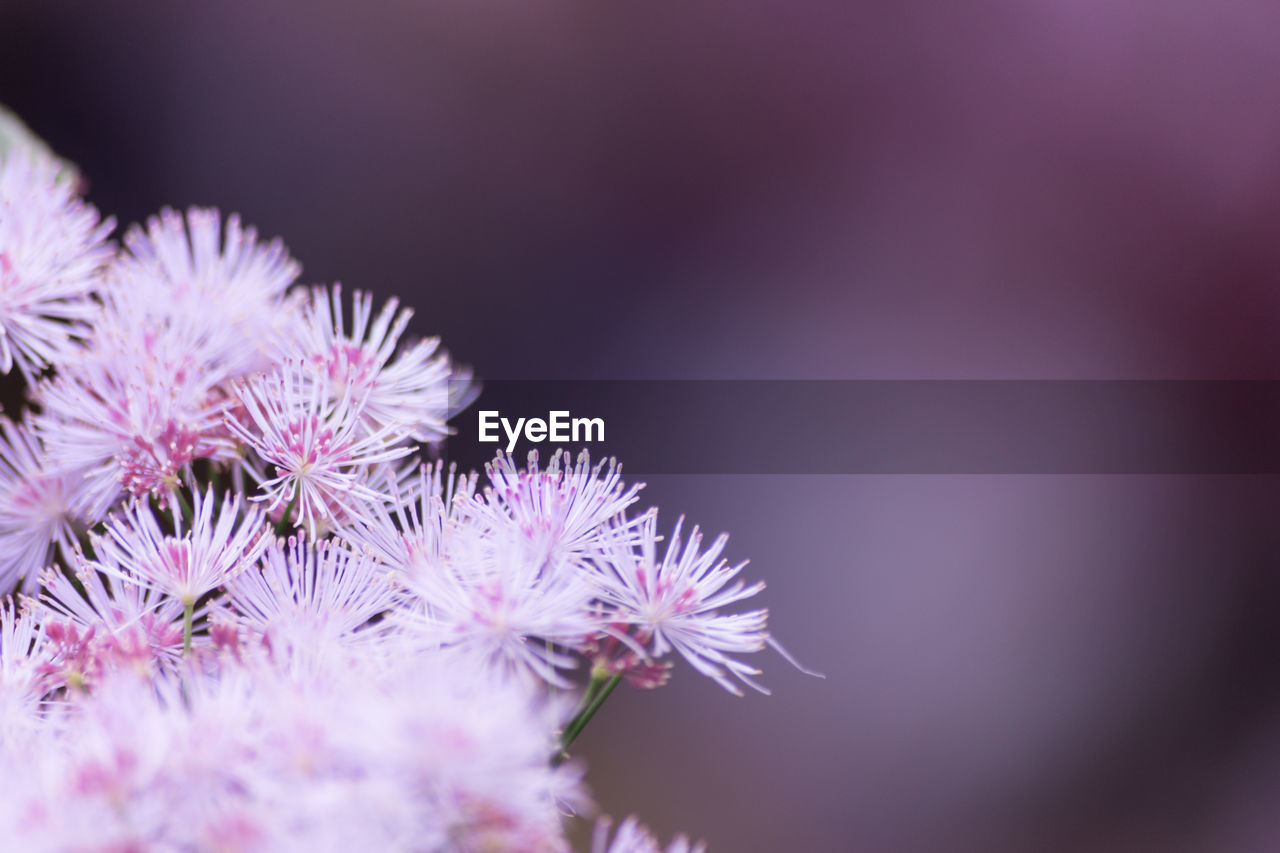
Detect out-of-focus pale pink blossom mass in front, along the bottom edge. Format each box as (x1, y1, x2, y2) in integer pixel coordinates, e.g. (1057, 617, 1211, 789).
(0, 648, 588, 853)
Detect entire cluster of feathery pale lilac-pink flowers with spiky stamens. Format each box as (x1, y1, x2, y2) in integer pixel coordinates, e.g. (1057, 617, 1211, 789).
(0, 136, 798, 853)
